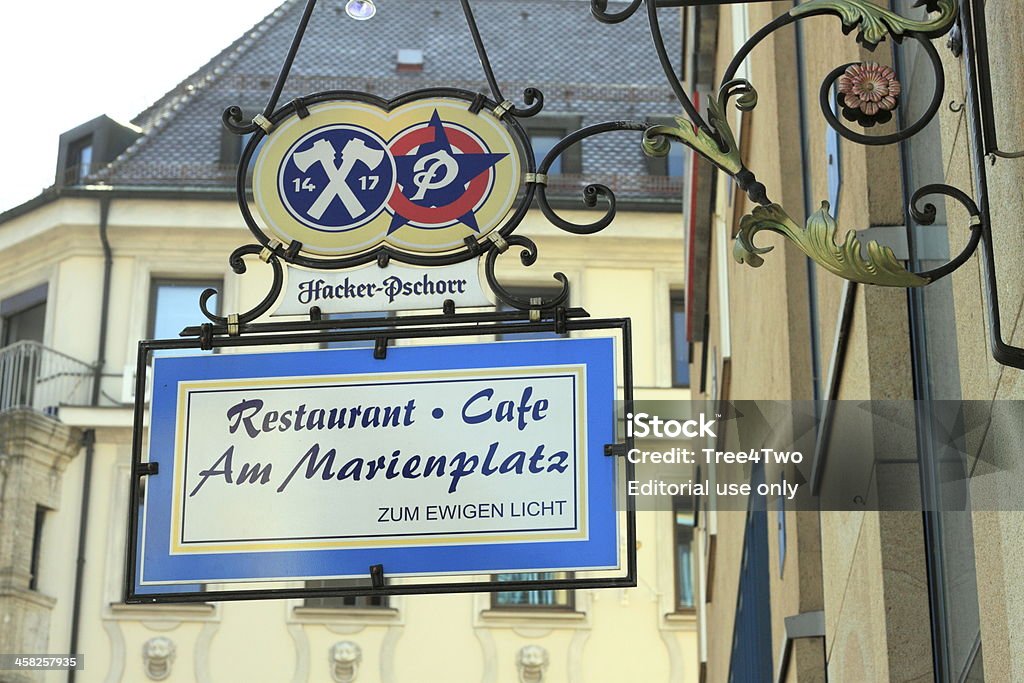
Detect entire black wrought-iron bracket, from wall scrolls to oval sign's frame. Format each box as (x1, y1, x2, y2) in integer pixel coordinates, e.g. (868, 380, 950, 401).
(201, 0, 1024, 368)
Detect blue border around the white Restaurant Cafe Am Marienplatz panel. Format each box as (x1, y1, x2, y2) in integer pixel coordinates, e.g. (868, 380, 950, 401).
(134, 338, 620, 594)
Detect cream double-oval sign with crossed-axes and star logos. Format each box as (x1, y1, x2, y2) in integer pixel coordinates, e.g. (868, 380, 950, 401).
(252, 96, 523, 264)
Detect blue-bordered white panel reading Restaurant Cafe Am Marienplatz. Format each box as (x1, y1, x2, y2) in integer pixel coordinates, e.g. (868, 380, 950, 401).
(136, 338, 620, 587)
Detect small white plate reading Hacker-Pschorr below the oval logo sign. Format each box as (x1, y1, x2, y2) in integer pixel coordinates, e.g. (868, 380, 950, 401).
(270, 261, 494, 315)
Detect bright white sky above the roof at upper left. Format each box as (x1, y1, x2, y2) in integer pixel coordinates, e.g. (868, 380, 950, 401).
(0, 0, 284, 211)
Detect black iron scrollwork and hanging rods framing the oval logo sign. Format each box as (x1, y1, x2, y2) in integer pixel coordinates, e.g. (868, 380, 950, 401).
(201, 0, 688, 321)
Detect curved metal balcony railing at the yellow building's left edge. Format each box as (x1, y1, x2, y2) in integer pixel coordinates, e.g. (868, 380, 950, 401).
(0, 341, 93, 417)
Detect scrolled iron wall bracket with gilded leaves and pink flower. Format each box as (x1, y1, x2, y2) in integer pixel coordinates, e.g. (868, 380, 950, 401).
(591, 0, 1024, 369)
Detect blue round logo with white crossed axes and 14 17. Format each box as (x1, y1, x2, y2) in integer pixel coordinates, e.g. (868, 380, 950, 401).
(278, 124, 395, 232)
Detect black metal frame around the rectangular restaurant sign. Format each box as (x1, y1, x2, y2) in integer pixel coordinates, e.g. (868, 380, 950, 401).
(123, 308, 637, 604)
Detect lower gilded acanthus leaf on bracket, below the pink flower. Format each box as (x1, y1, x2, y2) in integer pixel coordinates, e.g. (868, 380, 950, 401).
(732, 202, 931, 287)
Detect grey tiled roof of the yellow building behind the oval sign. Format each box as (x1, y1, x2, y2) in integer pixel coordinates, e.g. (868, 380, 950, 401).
(95, 0, 680, 197)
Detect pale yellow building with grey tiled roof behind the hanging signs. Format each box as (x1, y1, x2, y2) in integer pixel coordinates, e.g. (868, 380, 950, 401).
(0, 0, 698, 683)
